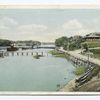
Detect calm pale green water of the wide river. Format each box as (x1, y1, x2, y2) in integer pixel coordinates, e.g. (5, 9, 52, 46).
(0, 49, 75, 91)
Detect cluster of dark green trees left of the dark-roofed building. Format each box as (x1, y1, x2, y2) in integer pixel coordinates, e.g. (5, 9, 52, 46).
(55, 36, 85, 50)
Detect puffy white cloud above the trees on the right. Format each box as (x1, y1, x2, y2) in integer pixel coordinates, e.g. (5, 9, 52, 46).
(62, 19, 99, 36)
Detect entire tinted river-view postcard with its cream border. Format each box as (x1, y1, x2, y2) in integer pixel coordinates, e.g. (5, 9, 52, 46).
(0, 5, 100, 94)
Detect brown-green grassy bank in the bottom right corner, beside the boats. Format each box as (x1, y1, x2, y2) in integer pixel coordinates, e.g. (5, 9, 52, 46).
(78, 65, 100, 92)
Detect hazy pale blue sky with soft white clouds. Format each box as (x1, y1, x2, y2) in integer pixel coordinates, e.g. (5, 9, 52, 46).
(0, 9, 100, 41)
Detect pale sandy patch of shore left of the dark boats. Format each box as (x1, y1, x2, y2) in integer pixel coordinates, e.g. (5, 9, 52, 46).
(59, 79, 75, 92)
